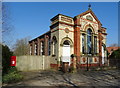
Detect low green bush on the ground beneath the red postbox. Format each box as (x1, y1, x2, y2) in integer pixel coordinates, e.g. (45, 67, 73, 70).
(2, 67, 23, 83)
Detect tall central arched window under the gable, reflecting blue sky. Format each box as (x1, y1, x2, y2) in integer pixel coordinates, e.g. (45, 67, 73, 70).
(87, 28, 92, 54)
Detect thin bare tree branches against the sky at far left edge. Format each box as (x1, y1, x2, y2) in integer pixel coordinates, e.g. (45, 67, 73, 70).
(0, 3, 14, 46)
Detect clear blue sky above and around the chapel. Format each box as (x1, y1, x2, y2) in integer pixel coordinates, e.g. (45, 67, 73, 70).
(3, 2, 118, 46)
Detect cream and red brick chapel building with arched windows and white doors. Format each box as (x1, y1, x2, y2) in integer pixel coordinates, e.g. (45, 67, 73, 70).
(29, 7, 107, 67)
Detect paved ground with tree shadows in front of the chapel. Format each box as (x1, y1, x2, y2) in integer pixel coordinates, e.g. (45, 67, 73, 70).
(2, 70, 120, 88)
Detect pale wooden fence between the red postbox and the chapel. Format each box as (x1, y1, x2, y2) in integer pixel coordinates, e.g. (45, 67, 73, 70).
(16, 56, 50, 71)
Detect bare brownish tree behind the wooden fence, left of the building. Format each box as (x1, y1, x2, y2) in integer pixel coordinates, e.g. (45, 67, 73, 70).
(14, 37, 30, 56)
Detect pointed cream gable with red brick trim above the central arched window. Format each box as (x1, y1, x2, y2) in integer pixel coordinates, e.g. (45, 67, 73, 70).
(76, 10, 101, 34)
